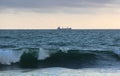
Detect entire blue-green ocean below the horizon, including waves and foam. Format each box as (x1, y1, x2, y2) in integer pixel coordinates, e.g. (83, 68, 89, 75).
(0, 30, 120, 76)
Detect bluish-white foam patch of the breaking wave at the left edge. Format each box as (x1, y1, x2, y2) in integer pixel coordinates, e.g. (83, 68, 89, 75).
(0, 49, 22, 65)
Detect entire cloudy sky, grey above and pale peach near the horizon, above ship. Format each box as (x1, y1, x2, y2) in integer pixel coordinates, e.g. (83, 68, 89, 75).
(0, 0, 120, 29)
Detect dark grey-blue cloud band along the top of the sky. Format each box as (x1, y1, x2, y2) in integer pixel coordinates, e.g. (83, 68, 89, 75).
(0, 0, 110, 8)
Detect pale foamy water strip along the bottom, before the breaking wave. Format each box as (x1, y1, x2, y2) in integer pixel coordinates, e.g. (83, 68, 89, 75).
(0, 68, 120, 76)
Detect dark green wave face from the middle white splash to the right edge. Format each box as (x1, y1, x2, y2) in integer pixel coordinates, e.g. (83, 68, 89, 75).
(39, 50, 120, 69)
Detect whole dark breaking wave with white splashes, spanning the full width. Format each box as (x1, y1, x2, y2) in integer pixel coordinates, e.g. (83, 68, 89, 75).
(0, 48, 120, 68)
